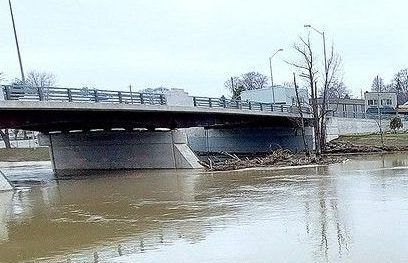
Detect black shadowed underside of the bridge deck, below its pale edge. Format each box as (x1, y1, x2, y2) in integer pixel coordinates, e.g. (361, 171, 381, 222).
(0, 110, 302, 133)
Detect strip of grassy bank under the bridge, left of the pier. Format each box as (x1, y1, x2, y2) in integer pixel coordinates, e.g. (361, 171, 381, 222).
(0, 147, 50, 162)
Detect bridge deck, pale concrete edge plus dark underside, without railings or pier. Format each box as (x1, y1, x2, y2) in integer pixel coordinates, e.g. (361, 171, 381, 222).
(0, 101, 310, 133)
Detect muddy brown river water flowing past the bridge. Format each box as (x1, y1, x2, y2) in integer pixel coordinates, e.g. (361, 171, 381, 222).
(0, 154, 408, 262)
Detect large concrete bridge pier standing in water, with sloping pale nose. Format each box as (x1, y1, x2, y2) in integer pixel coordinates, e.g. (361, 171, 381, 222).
(40, 130, 201, 175)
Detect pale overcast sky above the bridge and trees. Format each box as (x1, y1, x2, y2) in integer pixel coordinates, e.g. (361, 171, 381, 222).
(0, 0, 408, 96)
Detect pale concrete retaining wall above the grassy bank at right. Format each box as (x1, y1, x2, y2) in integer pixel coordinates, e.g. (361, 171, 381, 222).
(326, 117, 408, 141)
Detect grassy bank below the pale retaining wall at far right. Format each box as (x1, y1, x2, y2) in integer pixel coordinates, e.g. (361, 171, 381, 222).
(335, 133, 408, 148)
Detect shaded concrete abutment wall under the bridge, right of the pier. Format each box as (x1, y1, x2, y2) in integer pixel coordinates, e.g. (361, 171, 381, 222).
(186, 127, 313, 153)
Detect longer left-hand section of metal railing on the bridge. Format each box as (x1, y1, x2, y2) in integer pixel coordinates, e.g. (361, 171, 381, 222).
(3, 85, 166, 105)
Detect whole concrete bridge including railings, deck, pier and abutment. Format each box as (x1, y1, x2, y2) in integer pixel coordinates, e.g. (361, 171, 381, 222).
(0, 86, 312, 175)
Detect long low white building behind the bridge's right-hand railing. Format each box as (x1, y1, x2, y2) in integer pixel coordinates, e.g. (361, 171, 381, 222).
(241, 85, 309, 105)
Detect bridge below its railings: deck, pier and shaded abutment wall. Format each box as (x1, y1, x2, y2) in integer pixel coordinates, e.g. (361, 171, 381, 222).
(0, 101, 310, 174)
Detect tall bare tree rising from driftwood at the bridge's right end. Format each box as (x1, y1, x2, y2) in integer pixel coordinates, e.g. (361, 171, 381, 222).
(288, 35, 341, 156)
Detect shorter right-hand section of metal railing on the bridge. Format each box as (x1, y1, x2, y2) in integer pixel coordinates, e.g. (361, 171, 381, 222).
(193, 97, 310, 113)
